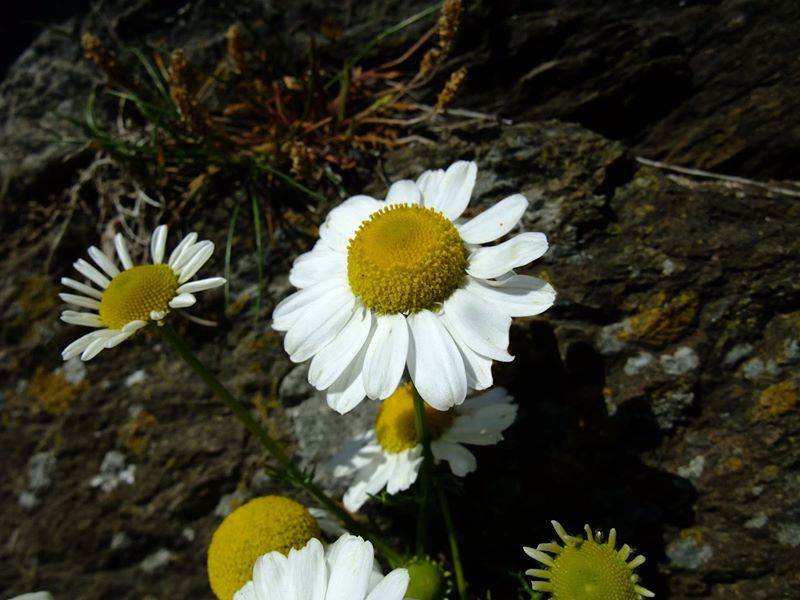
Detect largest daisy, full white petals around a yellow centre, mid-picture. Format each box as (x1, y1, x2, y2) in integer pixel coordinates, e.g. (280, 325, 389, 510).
(273, 161, 555, 413)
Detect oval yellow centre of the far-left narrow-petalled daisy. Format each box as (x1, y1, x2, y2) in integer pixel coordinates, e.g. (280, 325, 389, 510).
(99, 264, 178, 329)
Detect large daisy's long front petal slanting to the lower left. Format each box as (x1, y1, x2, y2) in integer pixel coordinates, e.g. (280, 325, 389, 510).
(308, 308, 373, 390)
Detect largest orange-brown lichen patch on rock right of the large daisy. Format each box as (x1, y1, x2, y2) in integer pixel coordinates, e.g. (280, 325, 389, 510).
(617, 290, 699, 347)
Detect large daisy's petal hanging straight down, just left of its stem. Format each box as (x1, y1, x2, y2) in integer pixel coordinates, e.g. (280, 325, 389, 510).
(364, 315, 408, 399)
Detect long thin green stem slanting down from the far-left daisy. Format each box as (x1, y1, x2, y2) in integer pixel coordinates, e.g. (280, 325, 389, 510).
(155, 324, 408, 567)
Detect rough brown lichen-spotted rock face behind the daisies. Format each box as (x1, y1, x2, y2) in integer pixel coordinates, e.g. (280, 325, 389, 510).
(0, 1, 800, 600)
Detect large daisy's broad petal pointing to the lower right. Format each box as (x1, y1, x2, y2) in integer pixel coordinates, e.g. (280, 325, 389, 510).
(441, 289, 514, 362)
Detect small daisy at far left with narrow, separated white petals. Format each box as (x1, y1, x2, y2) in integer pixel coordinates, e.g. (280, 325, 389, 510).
(59, 225, 225, 360)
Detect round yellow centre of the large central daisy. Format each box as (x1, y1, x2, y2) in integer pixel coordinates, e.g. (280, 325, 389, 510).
(347, 204, 467, 314)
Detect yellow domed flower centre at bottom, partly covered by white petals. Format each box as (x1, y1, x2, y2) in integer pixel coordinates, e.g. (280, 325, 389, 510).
(208, 496, 320, 600)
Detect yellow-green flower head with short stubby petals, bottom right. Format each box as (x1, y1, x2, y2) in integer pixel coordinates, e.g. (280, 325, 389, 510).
(524, 521, 655, 600)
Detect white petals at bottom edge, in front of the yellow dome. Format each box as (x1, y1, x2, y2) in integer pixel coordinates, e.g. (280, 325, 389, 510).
(233, 534, 409, 600)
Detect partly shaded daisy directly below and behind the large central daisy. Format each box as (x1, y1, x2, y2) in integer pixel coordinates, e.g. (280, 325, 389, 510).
(332, 383, 517, 512)
